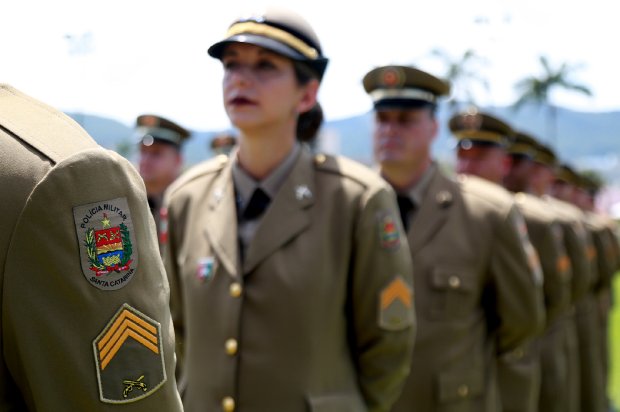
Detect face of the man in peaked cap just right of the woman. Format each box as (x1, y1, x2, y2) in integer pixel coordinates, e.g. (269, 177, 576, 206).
(373, 108, 437, 169)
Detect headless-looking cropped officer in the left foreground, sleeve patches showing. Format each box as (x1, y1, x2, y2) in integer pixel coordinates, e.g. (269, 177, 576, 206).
(0, 85, 182, 411)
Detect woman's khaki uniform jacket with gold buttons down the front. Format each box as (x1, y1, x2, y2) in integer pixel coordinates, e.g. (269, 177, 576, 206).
(165, 149, 414, 412)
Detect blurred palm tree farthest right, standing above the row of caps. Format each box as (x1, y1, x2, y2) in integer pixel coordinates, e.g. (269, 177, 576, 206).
(513, 56, 592, 143)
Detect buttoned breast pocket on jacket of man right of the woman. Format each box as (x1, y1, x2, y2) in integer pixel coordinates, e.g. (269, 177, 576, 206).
(429, 267, 480, 320)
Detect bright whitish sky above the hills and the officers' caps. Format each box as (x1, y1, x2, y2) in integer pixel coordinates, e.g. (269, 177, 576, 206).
(0, 0, 620, 130)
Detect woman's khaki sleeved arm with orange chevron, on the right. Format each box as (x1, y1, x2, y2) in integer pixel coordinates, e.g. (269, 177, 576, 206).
(349, 188, 415, 412)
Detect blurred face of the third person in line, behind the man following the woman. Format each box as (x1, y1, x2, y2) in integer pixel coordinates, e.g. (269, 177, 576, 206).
(456, 145, 510, 185)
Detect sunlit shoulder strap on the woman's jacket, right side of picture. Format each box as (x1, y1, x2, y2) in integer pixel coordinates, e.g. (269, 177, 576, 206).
(314, 153, 387, 189)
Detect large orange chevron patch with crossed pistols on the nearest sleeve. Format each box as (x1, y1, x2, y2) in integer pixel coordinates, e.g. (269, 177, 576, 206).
(93, 304, 166, 403)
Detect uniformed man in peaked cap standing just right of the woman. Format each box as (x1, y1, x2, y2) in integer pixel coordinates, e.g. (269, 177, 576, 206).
(363, 66, 543, 412)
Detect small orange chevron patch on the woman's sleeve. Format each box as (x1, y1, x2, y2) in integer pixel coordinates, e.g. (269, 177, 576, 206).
(379, 276, 413, 331)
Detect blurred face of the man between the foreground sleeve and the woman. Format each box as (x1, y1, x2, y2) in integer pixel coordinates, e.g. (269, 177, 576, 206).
(139, 142, 182, 189)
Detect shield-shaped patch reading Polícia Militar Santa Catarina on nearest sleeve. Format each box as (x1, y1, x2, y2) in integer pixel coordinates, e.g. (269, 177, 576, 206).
(73, 197, 138, 290)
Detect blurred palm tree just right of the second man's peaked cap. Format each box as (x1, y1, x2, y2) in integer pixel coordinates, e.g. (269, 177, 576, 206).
(431, 49, 489, 112)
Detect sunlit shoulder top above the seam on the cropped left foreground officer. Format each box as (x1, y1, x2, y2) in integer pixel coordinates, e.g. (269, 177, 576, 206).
(0, 85, 99, 163)
